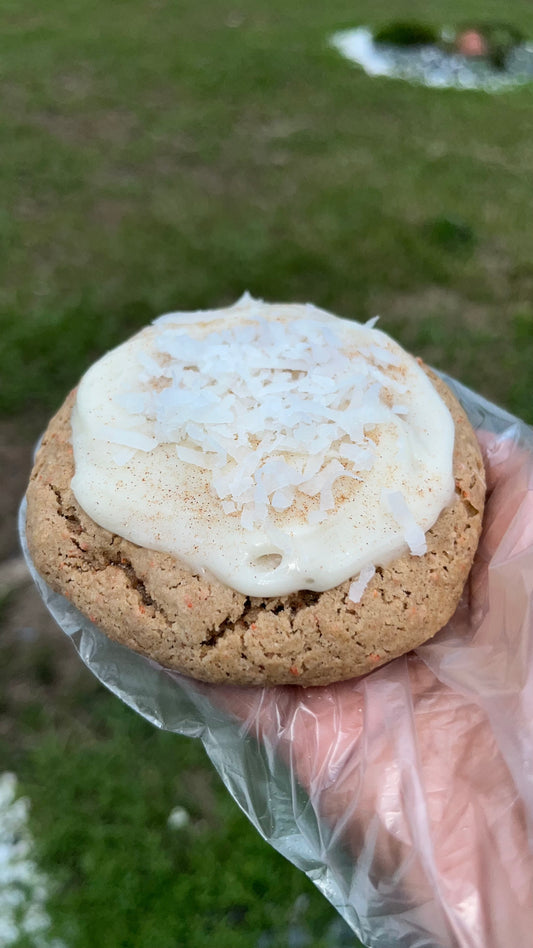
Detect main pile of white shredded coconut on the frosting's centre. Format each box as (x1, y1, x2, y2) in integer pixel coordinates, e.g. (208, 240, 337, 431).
(108, 314, 408, 529)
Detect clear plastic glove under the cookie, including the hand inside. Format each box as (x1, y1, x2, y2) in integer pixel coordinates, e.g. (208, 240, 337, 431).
(20, 377, 533, 948)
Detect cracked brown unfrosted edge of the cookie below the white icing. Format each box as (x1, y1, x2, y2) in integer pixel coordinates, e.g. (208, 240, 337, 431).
(27, 375, 485, 686)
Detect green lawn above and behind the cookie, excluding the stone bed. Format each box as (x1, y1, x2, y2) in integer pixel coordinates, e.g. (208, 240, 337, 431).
(0, 0, 533, 419)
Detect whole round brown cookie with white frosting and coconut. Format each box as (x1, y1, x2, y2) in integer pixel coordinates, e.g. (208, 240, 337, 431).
(27, 296, 485, 685)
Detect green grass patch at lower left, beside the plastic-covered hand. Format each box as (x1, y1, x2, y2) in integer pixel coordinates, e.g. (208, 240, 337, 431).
(18, 701, 352, 948)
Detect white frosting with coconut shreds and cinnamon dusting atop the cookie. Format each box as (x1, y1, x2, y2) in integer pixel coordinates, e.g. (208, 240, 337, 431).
(72, 295, 454, 601)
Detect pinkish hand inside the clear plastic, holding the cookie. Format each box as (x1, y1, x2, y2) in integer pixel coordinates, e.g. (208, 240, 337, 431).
(219, 432, 533, 948)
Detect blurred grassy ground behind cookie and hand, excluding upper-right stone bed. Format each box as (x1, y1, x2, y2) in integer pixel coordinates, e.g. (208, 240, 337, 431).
(0, 0, 533, 948)
